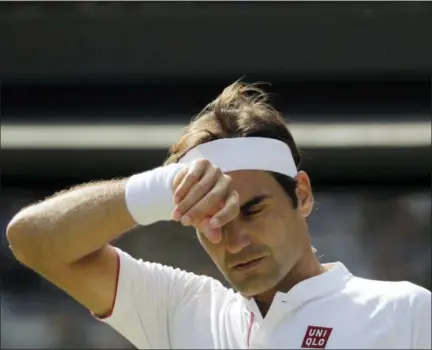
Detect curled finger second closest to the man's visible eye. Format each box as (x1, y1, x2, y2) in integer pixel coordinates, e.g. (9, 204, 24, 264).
(181, 176, 231, 226)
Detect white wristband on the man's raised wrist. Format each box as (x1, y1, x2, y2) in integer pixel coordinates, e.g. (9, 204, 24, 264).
(125, 164, 185, 225)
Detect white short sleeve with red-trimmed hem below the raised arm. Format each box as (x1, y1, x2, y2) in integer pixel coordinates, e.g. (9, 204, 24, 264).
(92, 249, 216, 349)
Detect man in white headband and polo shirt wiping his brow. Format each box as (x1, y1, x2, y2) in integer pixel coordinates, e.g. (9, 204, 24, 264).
(7, 83, 431, 349)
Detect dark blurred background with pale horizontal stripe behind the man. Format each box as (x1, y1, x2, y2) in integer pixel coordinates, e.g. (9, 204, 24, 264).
(0, 1, 432, 349)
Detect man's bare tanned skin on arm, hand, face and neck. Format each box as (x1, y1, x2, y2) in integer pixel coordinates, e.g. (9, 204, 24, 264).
(7, 160, 322, 316)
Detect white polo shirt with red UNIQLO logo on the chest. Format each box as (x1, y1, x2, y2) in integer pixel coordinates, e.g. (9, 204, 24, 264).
(98, 250, 431, 349)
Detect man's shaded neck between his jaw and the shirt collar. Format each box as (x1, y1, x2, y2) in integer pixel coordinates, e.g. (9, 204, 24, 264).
(254, 250, 326, 316)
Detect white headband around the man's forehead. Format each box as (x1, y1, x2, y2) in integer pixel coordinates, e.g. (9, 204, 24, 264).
(178, 137, 297, 178)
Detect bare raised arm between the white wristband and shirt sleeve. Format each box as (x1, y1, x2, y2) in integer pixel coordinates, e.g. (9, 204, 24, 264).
(7, 180, 136, 314)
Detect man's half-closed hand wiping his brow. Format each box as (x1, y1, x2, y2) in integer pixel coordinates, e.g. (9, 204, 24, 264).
(172, 159, 240, 243)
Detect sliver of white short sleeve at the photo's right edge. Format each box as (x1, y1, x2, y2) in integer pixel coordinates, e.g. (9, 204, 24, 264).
(410, 286, 432, 349)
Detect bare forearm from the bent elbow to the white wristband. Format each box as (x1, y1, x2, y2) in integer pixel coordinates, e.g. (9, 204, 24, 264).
(7, 180, 136, 263)
